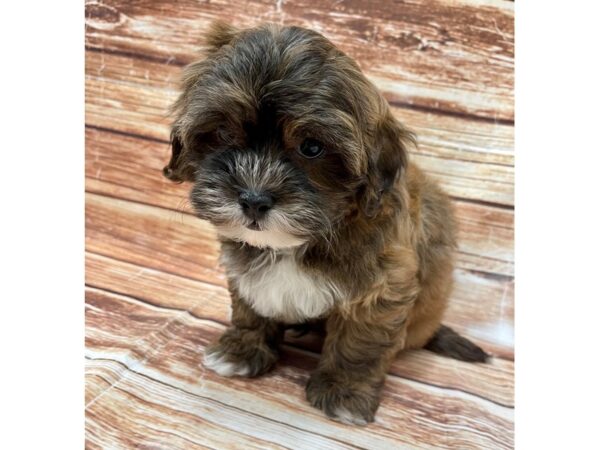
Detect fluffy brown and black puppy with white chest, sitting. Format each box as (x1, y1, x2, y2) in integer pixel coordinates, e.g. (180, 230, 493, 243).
(164, 23, 487, 424)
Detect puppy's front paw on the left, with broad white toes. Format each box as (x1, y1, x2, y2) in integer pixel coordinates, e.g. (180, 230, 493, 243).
(203, 327, 278, 377)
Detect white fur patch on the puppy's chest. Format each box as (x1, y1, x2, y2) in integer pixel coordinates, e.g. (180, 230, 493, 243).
(235, 254, 340, 323)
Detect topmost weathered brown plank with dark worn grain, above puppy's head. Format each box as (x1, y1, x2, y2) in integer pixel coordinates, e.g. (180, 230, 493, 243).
(86, 0, 514, 120)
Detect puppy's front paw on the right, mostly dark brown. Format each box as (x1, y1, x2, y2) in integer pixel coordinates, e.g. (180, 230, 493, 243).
(306, 370, 383, 425)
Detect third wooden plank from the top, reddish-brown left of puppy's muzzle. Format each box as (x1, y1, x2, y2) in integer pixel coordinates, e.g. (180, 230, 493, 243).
(86, 129, 514, 276)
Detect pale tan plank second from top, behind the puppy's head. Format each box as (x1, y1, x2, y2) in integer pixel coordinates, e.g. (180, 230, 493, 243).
(86, 51, 514, 206)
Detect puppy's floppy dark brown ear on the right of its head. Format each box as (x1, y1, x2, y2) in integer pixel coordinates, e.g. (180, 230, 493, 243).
(360, 111, 415, 217)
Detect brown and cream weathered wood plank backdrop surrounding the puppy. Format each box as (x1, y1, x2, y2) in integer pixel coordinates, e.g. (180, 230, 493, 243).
(85, 0, 514, 449)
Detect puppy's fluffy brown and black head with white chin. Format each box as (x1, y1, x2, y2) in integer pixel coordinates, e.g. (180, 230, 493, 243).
(165, 24, 409, 248)
